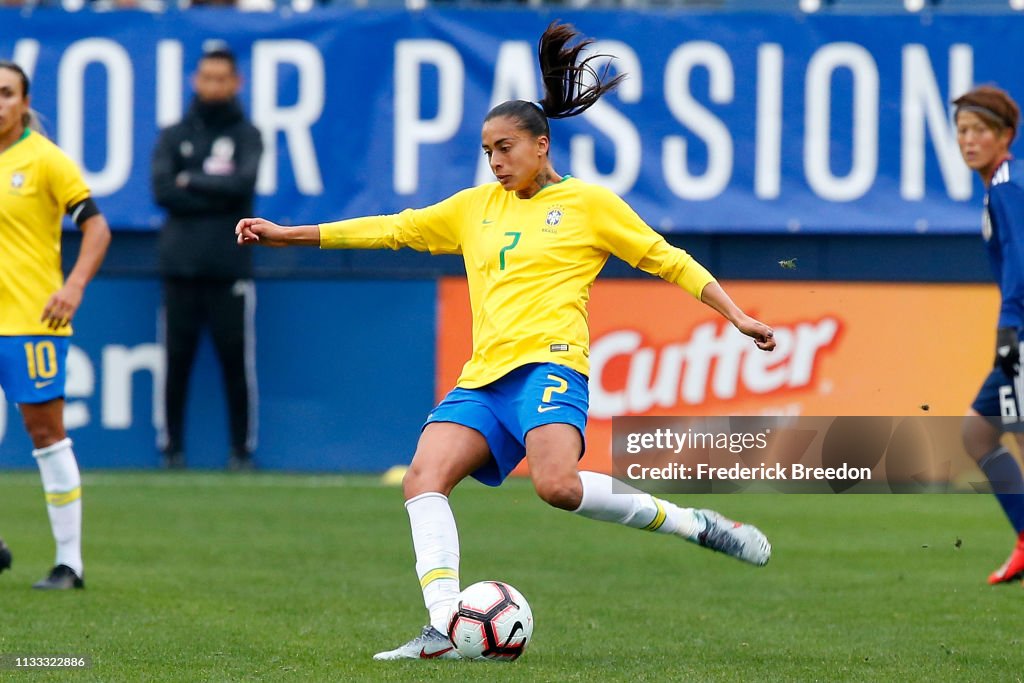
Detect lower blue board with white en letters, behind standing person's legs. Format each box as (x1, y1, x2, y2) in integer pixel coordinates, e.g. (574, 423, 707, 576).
(0, 278, 436, 472)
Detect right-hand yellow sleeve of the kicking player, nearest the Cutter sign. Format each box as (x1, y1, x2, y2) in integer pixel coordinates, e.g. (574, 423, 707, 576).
(590, 185, 715, 299)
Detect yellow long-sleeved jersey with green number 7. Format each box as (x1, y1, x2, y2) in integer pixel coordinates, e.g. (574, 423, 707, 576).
(319, 176, 714, 388)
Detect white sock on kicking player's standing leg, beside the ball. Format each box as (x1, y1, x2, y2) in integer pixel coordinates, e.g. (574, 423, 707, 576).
(406, 493, 459, 633)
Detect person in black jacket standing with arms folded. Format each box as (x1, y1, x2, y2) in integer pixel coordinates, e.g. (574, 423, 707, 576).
(153, 49, 263, 469)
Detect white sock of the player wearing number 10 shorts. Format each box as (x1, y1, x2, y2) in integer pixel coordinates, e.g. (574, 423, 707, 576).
(32, 438, 82, 577)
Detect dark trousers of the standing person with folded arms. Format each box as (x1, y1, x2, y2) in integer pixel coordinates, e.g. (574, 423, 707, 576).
(161, 279, 256, 457)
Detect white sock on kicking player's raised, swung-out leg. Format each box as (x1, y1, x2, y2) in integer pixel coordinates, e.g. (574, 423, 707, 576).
(573, 472, 705, 541)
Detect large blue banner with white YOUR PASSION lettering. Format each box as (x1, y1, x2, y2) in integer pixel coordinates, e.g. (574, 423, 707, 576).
(0, 9, 1024, 233)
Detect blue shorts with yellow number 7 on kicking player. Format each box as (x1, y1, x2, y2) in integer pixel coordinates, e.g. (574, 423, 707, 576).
(424, 362, 590, 486)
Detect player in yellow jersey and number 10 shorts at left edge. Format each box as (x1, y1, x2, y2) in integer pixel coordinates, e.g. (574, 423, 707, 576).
(0, 61, 111, 589)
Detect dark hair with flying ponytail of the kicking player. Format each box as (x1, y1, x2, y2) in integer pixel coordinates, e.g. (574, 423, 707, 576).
(484, 22, 626, 136)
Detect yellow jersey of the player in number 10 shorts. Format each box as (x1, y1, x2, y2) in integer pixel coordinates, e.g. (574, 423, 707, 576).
(0, 131, 89, 336)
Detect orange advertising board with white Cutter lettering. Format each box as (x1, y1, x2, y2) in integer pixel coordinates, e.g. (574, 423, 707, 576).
(436, 278, 998, 471)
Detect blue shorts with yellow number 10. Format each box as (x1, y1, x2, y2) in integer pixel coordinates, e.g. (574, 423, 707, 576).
(0, 335, 71, 403)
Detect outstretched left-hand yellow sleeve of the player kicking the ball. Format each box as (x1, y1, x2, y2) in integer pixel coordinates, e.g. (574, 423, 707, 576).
(318, 190, 469, 254)
